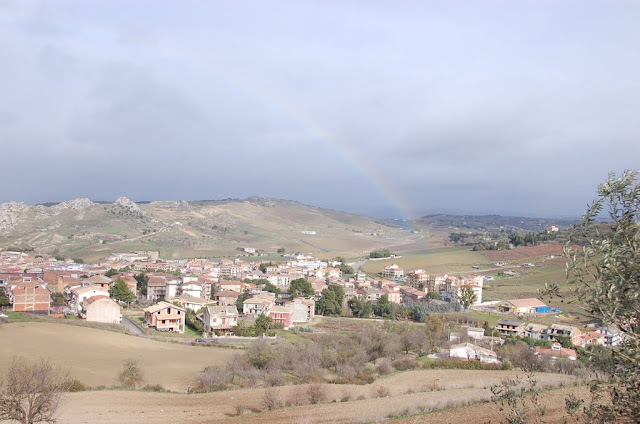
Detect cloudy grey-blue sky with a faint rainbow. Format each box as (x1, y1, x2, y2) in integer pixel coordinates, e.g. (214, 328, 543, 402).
(0, 0, 640, 218)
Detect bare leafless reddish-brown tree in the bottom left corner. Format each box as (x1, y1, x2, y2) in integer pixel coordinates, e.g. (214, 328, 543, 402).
(0, 357, 67, 424)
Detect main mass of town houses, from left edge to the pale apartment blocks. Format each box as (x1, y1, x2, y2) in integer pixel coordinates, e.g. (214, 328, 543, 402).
(0, 252, 490, 333)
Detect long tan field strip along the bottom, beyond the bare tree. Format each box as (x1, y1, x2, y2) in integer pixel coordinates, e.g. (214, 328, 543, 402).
(60, 370, 574, 423)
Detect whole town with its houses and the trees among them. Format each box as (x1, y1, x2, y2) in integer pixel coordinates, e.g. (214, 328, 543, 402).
(0, 249, 621, 363)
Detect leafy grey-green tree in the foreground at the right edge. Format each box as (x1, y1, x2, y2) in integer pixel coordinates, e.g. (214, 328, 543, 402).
(543, 171, 640, 423)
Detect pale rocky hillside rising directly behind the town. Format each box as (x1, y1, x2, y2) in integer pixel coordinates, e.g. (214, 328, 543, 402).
(0, 197, 418, 260)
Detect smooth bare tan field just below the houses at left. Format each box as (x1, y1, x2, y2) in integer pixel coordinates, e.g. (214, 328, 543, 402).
(0, 322, 237, 394)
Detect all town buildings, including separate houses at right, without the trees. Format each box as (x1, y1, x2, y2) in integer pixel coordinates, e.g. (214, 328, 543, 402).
(0, 252, 620, 363)
